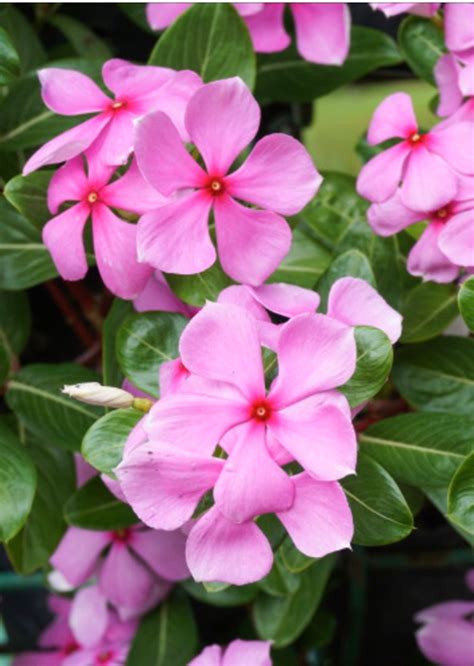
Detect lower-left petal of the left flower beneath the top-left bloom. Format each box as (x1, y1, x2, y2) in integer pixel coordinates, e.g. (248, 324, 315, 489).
(43, 203, 89, 280)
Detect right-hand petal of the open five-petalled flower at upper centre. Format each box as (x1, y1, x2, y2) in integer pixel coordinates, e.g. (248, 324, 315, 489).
(225, 134, 322, 215)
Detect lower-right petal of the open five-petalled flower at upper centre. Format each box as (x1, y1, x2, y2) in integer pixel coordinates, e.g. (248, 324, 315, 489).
(214, 194, 291, 286)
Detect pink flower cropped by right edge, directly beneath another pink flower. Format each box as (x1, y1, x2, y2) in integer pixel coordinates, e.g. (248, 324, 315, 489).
(367, 178, 474, 282)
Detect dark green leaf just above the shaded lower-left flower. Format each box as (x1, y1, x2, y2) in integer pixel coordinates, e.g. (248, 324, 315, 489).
(64, 476, 138, 530)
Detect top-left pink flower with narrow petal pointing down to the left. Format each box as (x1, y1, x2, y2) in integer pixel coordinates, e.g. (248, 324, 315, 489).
(23, 58, 201, 175)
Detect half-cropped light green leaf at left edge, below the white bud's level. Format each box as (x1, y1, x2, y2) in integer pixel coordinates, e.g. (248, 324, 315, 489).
(0, 417, 36, 541)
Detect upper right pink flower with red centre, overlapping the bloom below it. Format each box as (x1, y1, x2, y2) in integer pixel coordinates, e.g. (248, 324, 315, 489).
(357, 93, 474, 211)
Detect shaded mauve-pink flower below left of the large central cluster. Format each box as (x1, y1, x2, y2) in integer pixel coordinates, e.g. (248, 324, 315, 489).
(50, 526, 189, 619)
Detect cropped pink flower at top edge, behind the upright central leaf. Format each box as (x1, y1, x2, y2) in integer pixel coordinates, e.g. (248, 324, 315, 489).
(146, 2, 351, 65)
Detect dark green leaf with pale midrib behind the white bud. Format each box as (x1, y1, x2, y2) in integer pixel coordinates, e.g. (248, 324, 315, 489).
(6, 363, 103, 451)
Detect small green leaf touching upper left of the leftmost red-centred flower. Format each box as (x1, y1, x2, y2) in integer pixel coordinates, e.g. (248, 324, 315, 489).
(3, 170, 53, 229)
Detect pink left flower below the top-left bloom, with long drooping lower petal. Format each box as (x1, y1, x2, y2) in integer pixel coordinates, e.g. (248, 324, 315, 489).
(43, 154, 165, 299)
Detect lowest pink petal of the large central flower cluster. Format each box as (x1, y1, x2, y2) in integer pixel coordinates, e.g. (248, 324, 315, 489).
(186, 506, 273, 585)
